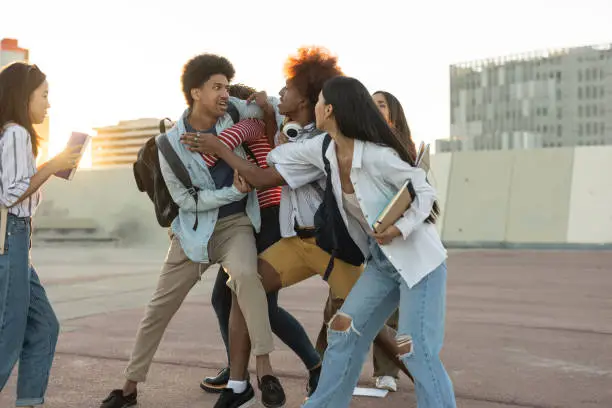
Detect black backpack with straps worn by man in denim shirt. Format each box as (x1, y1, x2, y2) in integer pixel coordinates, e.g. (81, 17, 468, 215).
(133, 103, 244, 230)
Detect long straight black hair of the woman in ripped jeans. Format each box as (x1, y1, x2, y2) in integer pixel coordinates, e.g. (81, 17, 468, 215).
(322, 76, 440, 224)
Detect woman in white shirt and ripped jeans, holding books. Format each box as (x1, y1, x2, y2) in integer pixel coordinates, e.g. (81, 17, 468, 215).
(268, 77, 456, 408)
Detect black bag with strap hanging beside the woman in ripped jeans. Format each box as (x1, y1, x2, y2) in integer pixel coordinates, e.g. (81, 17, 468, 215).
(314, 134, 365, 280)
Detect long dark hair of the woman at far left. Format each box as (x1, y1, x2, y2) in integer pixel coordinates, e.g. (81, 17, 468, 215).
(0, 62, 47, 156)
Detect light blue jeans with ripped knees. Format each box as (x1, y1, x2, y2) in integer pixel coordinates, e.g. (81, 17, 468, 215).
(303, 243, 457, 408)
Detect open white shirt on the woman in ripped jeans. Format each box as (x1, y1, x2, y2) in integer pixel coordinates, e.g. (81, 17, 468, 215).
(268, 135, 446, 287)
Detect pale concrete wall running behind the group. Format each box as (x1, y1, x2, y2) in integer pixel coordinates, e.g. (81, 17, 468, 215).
(37, 146, 612, 247)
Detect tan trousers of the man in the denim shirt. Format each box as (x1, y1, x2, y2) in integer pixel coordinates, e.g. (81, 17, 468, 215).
(125, 214, 273, 382)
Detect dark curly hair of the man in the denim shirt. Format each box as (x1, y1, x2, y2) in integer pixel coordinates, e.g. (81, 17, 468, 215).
(181, 54, 236, 107)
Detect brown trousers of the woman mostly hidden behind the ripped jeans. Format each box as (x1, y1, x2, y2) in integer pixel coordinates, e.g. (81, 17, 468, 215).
(316, 290, 399, 378)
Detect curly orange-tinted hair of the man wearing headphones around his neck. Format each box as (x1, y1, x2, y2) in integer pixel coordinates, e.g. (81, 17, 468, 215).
(284, 46, 344, 109)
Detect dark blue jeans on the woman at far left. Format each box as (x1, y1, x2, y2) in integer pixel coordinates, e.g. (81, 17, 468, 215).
(0, 215, 59, 407)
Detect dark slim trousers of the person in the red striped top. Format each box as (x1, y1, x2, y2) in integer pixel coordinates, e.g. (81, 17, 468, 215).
(211, 206, 321, 370)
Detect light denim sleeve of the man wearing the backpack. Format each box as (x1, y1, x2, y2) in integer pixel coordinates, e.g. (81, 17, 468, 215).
(158, 148, 246, 212)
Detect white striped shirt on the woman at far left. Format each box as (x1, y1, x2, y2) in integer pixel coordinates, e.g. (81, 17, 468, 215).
(0, 125, 41, 217)
